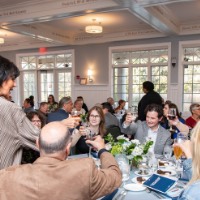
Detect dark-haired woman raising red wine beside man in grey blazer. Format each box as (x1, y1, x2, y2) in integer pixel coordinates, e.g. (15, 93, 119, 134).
(161, 102, 189, 139)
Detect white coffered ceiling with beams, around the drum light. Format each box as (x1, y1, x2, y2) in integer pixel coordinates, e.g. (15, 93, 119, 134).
(0, 0, 200, 51)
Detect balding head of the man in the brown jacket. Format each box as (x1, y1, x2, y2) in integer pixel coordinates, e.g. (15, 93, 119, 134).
(39, 122, 71, 154)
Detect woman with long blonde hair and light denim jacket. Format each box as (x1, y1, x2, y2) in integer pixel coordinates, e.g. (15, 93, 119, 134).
(178, 122, 200, 200)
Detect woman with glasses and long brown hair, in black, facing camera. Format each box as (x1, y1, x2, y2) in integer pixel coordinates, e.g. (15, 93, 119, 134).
(76, 106, 106, 153)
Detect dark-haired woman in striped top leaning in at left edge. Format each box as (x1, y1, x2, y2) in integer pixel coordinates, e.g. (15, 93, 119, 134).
(0, 56, 40, 169)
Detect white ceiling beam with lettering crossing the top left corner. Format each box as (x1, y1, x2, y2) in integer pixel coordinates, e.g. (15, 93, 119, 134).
(0, 0, 117, 26)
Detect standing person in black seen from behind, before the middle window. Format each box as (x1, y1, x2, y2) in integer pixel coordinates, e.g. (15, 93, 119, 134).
(138, 81, 162, 121)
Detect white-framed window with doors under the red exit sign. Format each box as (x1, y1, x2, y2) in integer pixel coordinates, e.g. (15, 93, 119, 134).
(18, 51, 73, 107)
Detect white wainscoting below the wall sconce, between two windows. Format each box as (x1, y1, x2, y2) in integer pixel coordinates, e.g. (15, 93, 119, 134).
(72, 85, 111, 108)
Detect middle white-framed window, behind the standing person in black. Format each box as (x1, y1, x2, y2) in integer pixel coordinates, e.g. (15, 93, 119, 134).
(111, 45, 169, 109)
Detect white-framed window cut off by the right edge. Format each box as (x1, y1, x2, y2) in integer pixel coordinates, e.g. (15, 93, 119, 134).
(183, 44, 200, 111)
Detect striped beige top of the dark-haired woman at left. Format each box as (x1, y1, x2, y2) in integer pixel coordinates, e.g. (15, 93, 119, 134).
(0, 97, 40, 169)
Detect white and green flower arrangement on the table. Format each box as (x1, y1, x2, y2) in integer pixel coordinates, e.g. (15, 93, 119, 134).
(105, 133, 153, 165)
